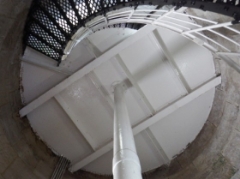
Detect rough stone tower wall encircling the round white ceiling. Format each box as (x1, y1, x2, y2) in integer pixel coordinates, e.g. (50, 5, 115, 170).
(0, 0, 240, 179)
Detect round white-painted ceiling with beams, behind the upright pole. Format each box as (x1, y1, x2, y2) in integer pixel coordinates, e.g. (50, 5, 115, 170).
(22, 27, 217, 174)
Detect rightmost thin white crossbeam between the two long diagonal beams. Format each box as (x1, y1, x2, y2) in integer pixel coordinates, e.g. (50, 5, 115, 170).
(152, 30, 191, 93)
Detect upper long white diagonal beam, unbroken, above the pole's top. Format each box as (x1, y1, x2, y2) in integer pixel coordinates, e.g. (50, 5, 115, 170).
(19, 25, 155, 117)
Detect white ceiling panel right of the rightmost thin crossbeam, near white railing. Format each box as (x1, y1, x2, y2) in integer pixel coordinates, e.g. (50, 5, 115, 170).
(158, 28, 215, 89)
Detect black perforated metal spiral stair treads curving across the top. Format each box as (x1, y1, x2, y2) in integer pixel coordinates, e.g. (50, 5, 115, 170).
(24, 0, 240, 63)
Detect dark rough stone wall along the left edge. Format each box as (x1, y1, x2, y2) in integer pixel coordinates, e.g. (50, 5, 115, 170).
(0, 0, 56, 179)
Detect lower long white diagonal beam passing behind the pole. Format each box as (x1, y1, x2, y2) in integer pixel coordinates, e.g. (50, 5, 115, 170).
(69, 76, 221, 172)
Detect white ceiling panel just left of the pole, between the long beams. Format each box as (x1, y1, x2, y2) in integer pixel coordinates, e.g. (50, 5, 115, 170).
(57, 77, 113, 149)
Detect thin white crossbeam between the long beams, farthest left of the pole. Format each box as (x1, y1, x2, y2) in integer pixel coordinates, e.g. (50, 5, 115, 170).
(55, 95, 98, 151)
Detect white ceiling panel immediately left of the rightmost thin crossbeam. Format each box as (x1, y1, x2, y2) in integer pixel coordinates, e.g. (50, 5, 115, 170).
(120, 32, 187, 110)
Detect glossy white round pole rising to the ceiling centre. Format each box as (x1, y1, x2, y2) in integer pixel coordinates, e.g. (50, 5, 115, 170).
(112, 83, 142, 179)
